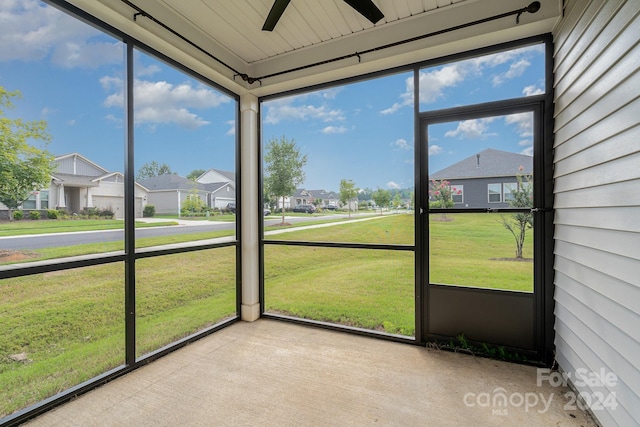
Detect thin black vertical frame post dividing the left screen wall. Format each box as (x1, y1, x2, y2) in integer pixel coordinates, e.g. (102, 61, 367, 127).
(124, 41, 136, 365)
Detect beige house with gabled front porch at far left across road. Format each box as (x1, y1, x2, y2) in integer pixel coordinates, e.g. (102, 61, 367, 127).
(0, 153, 147, 219)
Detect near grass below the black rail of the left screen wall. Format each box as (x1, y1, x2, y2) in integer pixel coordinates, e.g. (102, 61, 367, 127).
(0, 247, 236, 418)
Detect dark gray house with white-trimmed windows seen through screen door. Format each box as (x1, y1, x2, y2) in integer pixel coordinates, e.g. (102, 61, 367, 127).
(429, 148, 533, 208)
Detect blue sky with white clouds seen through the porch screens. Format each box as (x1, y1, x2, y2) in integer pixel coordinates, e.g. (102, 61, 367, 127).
(0, 0, 544, 191)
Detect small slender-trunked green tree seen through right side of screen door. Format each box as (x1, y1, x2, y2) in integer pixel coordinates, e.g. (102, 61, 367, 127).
(500, 171, 533, 259)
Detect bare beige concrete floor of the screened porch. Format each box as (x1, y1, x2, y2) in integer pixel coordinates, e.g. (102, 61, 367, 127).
(28, 320, 595, 427)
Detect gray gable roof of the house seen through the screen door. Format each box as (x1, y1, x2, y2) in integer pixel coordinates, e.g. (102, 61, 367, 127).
(429, 148, 533, 179)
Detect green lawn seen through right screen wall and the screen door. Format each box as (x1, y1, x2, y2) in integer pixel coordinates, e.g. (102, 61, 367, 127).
(265, 214, 533, 336)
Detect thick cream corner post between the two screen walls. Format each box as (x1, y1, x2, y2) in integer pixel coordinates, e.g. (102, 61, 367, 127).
(236, 94, 262, 322)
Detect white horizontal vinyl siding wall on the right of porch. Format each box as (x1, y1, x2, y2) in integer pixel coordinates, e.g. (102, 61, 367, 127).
(554, 0, 640, 426)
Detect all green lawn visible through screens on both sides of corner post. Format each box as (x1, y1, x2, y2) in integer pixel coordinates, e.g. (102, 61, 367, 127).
(0, 214, 532, 417)
